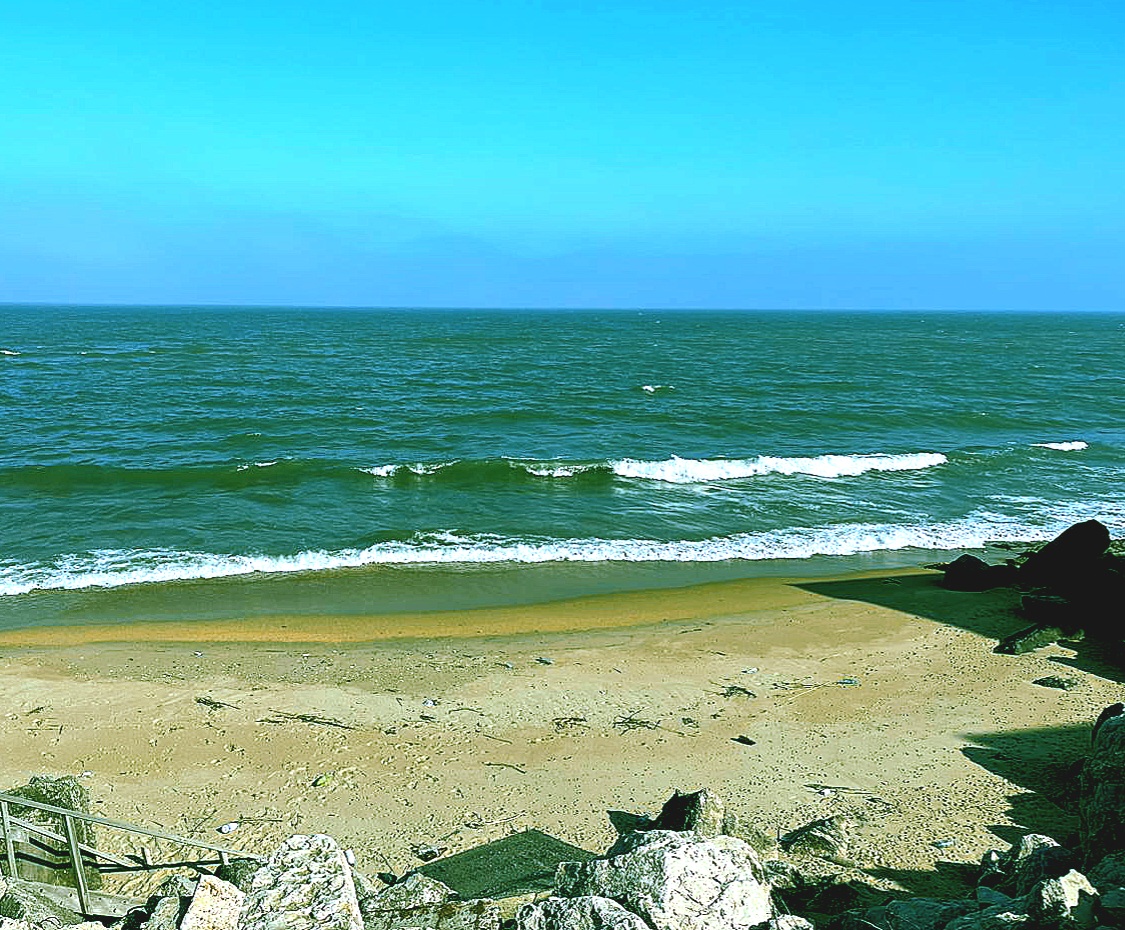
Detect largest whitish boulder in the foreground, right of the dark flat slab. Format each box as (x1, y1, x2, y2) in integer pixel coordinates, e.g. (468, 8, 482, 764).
(556, 830, 773, 930)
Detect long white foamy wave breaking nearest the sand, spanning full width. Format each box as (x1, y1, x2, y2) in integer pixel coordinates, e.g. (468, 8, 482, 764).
(0, 504, 1125, 596)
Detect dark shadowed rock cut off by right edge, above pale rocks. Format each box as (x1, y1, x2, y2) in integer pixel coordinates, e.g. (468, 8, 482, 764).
(1078, 705, 1125, 863)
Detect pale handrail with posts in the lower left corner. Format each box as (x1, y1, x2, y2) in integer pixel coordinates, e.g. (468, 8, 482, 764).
(0, 792, 264, 917)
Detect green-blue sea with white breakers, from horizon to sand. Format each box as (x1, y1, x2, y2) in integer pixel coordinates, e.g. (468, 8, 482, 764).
(0, 305, 1125, 629)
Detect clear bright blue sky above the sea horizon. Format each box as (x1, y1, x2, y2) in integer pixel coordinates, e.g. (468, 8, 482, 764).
(0, 0, 1125, 310)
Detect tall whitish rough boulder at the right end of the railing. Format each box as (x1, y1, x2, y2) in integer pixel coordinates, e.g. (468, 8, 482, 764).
(239, 834, 363, 930)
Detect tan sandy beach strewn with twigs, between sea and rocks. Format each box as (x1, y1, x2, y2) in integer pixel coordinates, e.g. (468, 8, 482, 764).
(0, 571, 1121, 894)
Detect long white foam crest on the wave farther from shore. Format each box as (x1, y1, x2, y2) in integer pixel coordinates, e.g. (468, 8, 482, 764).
(611, 452, 948, 485)
